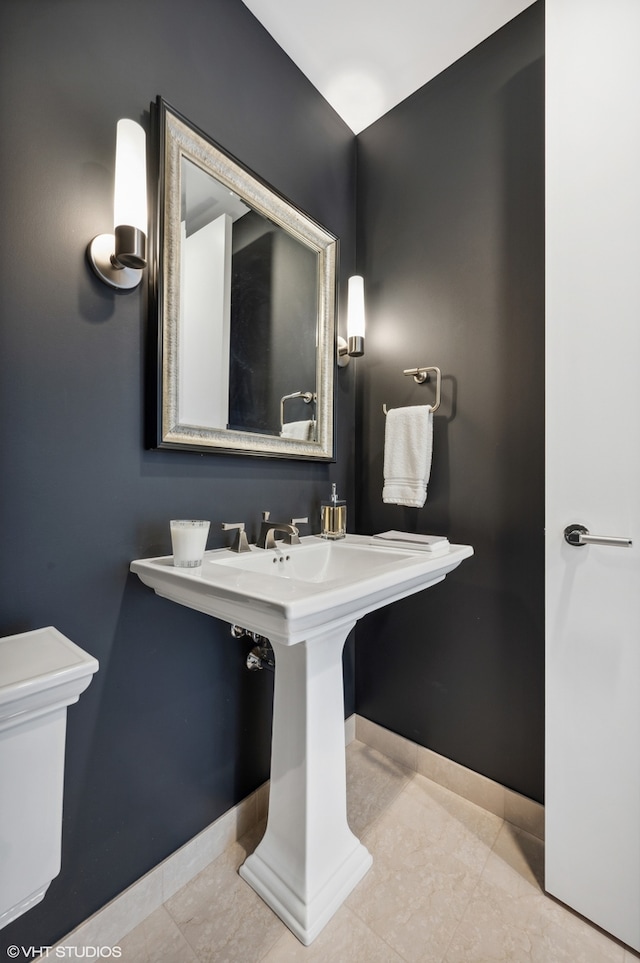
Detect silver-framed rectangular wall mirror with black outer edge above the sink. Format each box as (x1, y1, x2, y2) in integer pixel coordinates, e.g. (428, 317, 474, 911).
(154, 98, 338, 461)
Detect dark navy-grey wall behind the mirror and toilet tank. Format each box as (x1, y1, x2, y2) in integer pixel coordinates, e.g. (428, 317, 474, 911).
(0, 0, 355, 946)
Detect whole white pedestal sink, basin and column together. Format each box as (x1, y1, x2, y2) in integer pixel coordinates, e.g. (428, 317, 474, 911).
(131, 535, 473, 945)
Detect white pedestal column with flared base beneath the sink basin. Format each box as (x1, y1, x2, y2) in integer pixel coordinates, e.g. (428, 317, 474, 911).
(240, 621, 372, 945)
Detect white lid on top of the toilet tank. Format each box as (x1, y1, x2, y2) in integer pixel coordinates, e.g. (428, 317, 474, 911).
(0, 625, 98, 705)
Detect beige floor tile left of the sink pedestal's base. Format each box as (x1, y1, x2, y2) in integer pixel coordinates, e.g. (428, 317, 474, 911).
(165, 828, 285, 963)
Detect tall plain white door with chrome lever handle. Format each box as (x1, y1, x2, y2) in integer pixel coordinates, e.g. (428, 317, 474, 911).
(545, 0, 640, 949)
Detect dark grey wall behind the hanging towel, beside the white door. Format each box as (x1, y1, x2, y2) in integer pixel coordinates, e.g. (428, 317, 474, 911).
(356, 3, 544, 799)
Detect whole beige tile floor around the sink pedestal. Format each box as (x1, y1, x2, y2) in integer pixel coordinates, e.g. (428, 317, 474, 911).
(119, 741, 640, 963)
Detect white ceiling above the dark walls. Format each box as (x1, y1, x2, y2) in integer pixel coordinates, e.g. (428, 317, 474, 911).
(243, 0, 534, 134)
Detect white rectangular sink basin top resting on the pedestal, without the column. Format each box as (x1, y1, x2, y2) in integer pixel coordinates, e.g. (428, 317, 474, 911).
(131, 535, 473, 645)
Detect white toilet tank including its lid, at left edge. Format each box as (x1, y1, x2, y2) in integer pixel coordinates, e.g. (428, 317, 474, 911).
(0, 627, 98, 928)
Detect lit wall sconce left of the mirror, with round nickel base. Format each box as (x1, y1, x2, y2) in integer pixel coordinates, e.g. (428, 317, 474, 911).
(87, 120, 147, 291)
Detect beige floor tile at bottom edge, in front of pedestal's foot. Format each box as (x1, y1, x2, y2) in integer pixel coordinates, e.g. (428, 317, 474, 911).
(263, 906, 403, 963)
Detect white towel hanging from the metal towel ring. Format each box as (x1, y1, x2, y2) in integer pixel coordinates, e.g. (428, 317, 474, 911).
(382, 405, 433, 508)
